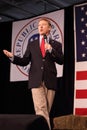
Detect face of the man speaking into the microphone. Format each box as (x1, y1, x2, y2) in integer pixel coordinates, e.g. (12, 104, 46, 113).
(38, 20, 51, 35)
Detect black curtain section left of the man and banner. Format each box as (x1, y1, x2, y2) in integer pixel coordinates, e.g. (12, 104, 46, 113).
(0, 22, 34, 114)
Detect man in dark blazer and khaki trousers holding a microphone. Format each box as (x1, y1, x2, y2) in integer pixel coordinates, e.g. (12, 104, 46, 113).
(3, 18, 64, 130)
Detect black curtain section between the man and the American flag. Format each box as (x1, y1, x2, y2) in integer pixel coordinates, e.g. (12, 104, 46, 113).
(51, 6, 74, 117)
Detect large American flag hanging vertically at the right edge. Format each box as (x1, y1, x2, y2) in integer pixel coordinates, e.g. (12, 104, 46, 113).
(74, 3, 87, 115)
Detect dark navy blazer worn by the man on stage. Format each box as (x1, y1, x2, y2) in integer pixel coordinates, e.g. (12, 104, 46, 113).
(13, 37, 64, 90)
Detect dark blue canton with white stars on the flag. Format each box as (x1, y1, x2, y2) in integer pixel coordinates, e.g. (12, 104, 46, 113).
(75, 3, 87, 62)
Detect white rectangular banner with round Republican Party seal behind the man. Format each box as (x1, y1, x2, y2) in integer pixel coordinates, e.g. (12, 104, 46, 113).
(10, 9, 64, 81)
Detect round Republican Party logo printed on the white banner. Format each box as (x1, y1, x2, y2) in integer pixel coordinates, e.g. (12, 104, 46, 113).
(13, 17, 63, 76)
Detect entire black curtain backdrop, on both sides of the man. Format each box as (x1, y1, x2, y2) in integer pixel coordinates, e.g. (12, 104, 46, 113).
(0, 6, 74, 117)
